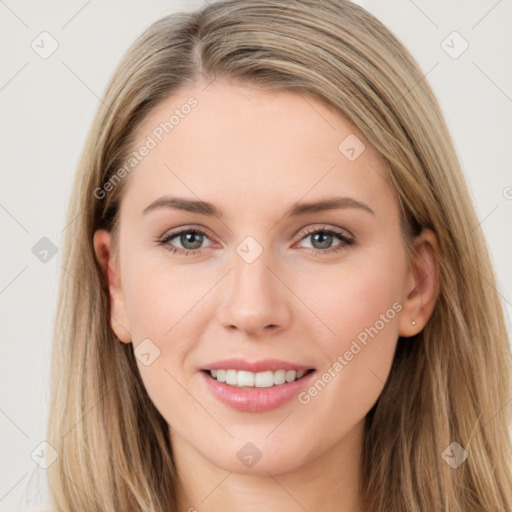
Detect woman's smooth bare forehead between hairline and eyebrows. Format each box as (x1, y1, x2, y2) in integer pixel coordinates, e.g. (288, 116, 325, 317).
(122, 79, 390, 218)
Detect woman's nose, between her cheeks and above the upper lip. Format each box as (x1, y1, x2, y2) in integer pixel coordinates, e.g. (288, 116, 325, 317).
(218, 247, 292, 337)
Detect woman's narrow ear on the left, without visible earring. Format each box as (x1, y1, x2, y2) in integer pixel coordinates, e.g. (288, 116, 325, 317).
(94, 229, 132, 343)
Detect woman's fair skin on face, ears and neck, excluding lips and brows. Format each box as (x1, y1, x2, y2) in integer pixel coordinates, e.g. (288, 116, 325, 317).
(94, 78, 438, 512)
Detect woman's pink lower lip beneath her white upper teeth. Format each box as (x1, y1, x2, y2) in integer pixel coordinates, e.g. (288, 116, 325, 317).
(201, 371, 316, 412)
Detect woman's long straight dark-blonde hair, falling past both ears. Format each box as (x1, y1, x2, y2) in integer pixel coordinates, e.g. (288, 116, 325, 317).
(48, 0, 512, 512)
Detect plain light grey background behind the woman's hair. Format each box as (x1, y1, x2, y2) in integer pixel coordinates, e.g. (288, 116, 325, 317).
(0, 0, 512, 511)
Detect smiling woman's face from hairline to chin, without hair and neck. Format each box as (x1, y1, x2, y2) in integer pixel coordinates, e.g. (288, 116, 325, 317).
(95, 79, 428, 473)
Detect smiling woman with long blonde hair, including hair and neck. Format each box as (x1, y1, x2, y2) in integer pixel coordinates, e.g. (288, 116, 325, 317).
(48, 0, 512, 512)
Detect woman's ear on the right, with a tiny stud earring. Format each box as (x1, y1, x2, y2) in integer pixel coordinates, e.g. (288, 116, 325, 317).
(398, 229, 439, 337)
